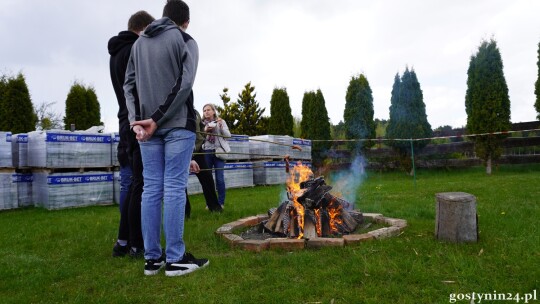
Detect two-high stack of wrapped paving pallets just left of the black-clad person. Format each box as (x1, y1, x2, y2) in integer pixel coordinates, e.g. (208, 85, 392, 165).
(28, 130, 114, 209)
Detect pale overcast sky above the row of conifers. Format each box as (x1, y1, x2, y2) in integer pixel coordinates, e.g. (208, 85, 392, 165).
(0, 0, 540, 131)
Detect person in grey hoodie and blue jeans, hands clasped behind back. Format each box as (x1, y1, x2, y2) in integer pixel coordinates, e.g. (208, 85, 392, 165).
(124, 0, 209, 276)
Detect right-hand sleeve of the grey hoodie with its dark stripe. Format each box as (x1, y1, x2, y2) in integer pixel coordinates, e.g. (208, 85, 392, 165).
(151, 39, 199, 126)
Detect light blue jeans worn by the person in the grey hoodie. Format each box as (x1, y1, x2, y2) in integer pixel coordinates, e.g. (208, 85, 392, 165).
(139, 128, 195, 263)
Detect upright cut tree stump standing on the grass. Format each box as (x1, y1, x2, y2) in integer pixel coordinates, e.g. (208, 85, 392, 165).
(435, 192, 478, 243)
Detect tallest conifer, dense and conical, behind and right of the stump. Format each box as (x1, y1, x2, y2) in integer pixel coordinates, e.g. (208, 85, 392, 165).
(465, 39, 511, 174)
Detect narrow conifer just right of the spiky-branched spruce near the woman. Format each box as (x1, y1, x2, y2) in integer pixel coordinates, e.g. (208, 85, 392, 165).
(268, 88, 293, 136)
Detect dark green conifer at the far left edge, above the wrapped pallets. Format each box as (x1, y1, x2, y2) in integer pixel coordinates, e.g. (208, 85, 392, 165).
(0, 74, 37, 134)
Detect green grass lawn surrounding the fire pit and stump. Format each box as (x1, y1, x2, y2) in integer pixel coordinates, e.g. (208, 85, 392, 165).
(0, 165, 540, 304)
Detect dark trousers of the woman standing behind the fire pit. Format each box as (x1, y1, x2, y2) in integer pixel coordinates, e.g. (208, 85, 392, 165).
(186, 154, 223, 217)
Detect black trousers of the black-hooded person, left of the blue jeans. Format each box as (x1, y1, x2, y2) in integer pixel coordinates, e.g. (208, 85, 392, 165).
(118, 126, 144, 248)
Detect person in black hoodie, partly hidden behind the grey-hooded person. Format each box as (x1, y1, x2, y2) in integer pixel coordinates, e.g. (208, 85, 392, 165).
(108, 11, 154, 258)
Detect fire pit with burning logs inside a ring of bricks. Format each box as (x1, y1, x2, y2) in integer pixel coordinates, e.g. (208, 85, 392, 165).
(216, 164, 407, 251)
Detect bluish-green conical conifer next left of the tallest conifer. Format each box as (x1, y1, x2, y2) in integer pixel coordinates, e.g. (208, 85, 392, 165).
(386, 68, 432, 170)
